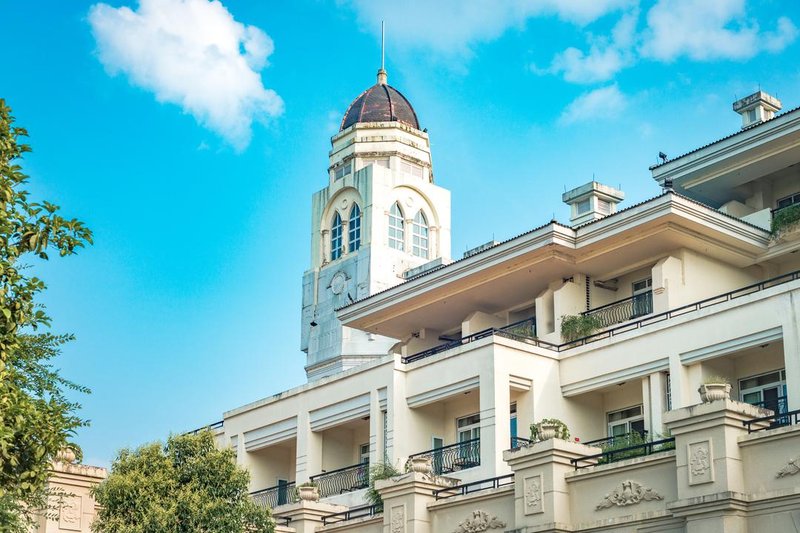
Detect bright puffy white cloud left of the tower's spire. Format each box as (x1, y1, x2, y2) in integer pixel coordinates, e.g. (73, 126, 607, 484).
(89, 0, 283, 150)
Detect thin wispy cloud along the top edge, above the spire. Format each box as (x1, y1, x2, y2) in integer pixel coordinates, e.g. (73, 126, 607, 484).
(340, 0, 636, 54)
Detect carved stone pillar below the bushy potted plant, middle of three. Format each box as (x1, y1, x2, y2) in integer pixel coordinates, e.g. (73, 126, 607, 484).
(503, 439, 600, 531)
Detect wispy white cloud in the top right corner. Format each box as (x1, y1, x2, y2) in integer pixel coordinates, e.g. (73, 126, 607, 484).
(641, 0, 797, 61)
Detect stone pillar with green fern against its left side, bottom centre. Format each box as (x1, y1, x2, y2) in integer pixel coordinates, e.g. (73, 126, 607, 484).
(375, 472, 450, 533)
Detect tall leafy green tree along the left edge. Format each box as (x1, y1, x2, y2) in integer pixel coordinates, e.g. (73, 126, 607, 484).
(0, 99, 92, 532)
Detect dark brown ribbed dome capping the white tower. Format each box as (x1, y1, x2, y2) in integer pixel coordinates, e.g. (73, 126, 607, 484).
(339, 69, 419, 131)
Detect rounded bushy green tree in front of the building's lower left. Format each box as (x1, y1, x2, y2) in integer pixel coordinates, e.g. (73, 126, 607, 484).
(92, 431, 275, 533)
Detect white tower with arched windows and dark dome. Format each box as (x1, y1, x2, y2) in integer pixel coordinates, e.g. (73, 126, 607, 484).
(301, 68, 450, 381)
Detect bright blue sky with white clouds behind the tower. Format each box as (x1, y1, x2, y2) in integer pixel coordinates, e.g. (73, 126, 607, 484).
(0, 0, 800, 465)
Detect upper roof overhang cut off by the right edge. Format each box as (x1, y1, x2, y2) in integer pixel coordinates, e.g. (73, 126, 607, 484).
(651, 110, 800, 207)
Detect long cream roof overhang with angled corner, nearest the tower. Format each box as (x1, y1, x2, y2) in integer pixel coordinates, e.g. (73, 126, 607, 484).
(337, 193, 769, 339)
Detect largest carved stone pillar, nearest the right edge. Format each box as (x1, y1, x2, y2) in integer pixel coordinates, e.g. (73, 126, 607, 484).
(664, 400, 764, 533)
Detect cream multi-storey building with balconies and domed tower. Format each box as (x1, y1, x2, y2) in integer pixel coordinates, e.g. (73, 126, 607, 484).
(208, 70, 800, 533)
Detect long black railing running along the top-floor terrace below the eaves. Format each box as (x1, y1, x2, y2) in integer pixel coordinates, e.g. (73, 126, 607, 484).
(402, 270, 800, 363)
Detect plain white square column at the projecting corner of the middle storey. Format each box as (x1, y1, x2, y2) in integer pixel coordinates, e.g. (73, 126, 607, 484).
(480, 365, 511, 477)
